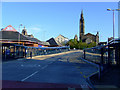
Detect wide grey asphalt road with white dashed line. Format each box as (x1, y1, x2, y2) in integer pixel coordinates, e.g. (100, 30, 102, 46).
(2, 50, 97, 88)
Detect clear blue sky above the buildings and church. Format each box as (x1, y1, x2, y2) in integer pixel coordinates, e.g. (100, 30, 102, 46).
(1, 2, 118, 42)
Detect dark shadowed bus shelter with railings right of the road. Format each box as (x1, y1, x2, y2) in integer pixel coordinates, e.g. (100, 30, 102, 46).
(83, 43, 120, 78)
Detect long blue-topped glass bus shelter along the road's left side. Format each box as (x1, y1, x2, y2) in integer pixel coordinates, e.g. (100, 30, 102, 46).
(0, 43, 69, 61)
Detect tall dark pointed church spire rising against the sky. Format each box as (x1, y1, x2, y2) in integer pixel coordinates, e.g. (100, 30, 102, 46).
(79, 10, 85, 40)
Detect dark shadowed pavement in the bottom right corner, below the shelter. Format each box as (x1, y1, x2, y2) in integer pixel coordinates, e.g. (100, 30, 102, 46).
(90, 66, 120, 90)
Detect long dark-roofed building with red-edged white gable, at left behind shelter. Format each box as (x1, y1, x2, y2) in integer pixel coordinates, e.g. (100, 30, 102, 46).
(0, 25, 49, 47)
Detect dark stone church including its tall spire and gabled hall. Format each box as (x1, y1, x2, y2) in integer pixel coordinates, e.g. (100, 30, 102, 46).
(79, 10, 99, 44)
